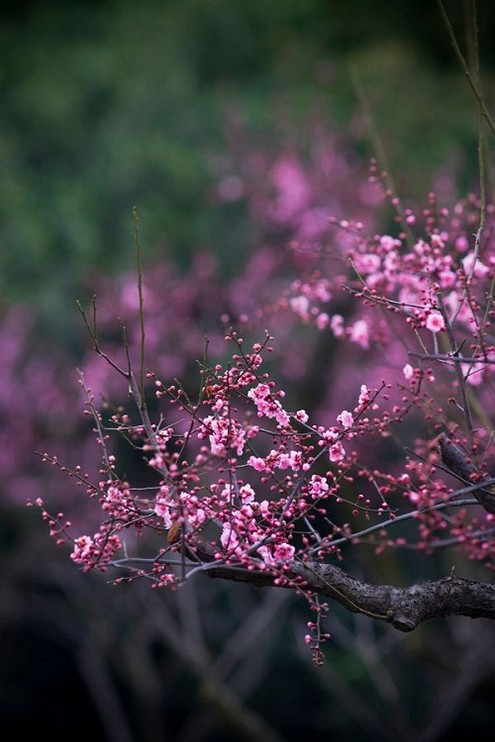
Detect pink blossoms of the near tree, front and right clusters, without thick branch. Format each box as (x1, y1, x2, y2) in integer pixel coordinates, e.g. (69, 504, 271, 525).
(34, 185, 495, 600)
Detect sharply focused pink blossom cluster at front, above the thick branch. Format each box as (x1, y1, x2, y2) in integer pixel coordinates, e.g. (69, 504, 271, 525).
(41, 332, 398, 584)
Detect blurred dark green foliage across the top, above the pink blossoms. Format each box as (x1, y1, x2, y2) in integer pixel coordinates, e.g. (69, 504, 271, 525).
(0, 0, 493, 338)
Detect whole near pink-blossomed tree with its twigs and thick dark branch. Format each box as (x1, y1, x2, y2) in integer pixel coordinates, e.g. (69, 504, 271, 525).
(32, 1, 495, 676)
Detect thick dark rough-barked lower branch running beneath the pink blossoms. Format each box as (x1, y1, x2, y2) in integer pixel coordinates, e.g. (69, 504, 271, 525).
(202, 562, 495, 631)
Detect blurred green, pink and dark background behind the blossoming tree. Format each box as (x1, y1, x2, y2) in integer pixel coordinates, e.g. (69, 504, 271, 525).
(0, 0, 495, 742)
